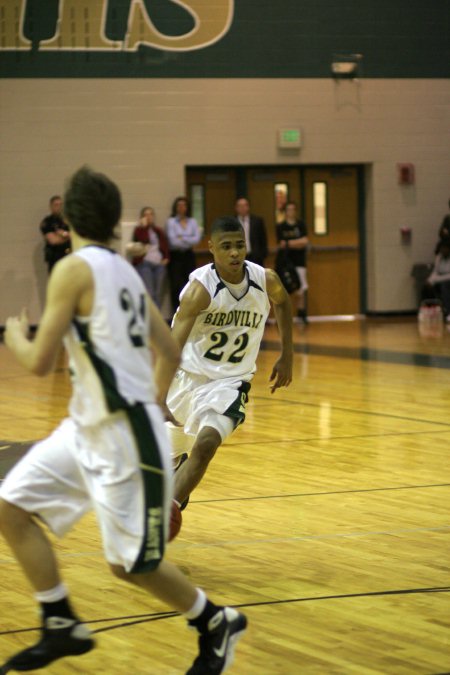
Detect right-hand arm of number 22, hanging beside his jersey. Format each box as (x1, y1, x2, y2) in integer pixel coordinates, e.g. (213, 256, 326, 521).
(266, 269, 294, 394)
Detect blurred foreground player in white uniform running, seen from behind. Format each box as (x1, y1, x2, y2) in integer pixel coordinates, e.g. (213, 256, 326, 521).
(0, 168, 246, 675)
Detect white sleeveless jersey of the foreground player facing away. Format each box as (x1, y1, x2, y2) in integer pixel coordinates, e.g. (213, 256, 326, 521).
(64, 246, 155, 426)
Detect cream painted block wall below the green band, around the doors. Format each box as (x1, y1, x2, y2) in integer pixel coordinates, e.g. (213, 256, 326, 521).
(0, 79, 450, 324)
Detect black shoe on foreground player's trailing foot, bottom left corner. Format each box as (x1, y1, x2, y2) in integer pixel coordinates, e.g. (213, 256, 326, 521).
(0, 616, 95, 674)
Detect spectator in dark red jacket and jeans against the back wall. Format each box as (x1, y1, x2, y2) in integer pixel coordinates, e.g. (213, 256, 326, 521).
(131, 206, 169, 309)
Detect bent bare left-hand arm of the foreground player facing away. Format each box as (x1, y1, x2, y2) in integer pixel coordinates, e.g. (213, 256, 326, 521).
(5, 256, 93, 376)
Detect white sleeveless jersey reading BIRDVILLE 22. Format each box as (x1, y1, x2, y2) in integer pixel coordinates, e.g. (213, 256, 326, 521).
(180, 261, 270, 381)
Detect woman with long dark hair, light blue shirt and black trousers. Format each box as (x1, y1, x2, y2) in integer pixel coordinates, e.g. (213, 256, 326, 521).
(166, 197, 202, 312)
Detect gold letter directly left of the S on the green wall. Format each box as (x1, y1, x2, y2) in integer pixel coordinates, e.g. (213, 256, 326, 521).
(39, 0, 122, 51)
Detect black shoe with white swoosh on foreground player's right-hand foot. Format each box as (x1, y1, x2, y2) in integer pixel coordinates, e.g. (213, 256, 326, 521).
(186, 607, 247, 675)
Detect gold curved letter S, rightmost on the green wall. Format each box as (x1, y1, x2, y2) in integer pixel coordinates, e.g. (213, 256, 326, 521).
(125, 0, 234, 52)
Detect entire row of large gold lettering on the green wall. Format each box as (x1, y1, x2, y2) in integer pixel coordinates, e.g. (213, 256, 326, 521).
(0, 0, 234, 52)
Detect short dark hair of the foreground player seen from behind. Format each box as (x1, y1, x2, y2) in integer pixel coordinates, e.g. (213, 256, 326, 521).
(64, 166, 122, 242)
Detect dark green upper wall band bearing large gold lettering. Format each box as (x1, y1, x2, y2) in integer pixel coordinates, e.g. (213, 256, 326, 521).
(0, 0, 450, 78)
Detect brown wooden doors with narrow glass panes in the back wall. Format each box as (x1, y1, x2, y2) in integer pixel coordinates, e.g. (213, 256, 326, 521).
(186, 166, 362, 316)
